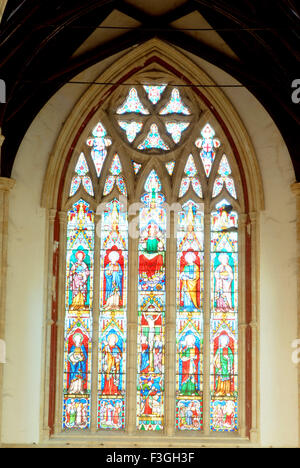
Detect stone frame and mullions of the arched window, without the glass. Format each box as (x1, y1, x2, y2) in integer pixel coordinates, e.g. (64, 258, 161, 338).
(43, 40, 263, 446)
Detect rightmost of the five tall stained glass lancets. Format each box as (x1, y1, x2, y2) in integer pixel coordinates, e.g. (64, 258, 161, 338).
(210, 200, 239, 432)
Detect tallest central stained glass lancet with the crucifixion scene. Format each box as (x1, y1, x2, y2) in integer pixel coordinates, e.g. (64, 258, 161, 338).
(137, 170, 166, 431)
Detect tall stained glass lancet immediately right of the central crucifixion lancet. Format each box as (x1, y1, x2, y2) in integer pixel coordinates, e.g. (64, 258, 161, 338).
(176, 200, 204, 431)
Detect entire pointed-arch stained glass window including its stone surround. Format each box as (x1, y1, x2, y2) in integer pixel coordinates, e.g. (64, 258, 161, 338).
(42, 39, 264, 444)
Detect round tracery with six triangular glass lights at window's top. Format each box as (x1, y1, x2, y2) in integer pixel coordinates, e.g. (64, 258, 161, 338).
(111, 82, 195, 154)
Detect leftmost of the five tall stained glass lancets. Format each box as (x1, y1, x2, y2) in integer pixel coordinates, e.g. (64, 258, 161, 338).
(63, 200, 94, 429)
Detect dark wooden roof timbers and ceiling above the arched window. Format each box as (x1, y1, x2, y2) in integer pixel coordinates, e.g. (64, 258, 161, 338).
(0, 0, 300, 181)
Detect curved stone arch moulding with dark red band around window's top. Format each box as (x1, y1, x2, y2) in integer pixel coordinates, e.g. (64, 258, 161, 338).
(41, 39, 264, 213)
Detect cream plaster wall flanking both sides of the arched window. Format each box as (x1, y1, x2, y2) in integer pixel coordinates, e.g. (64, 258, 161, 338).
(2, 47, 298, 446)
